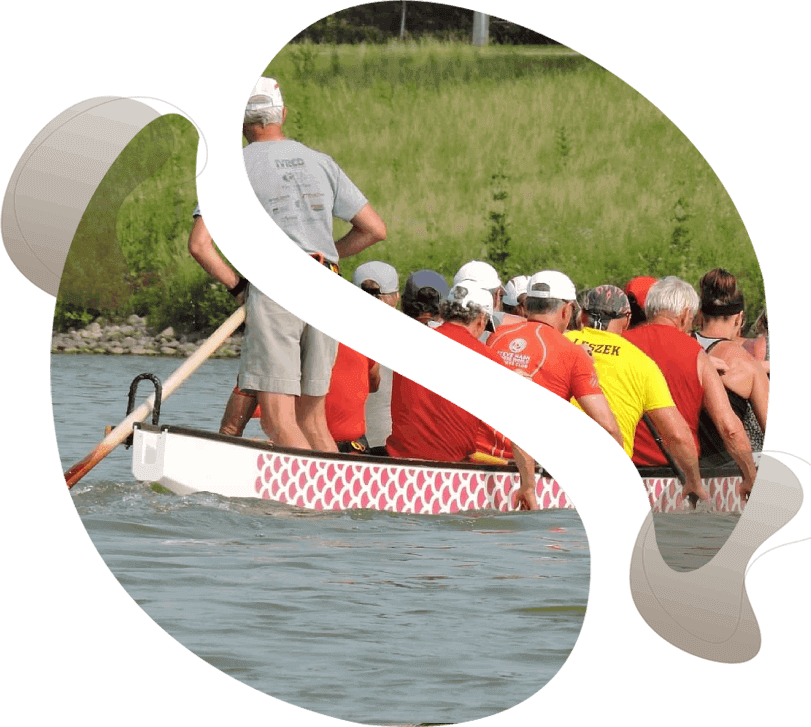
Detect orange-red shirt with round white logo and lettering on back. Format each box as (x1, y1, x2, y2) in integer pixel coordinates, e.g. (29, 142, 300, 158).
(487, 321, 603, 401)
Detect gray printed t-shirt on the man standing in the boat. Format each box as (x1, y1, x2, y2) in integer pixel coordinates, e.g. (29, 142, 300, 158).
(242, 139, 368, 263)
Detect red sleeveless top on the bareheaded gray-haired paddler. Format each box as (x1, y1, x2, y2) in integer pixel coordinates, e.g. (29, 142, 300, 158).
(623, 323, 704, 465)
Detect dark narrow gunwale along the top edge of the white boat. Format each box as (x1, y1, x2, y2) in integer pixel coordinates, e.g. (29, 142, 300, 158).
(133, 422, 742, 480)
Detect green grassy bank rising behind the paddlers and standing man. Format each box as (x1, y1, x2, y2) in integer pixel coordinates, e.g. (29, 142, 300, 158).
(54, 42, 765, 332)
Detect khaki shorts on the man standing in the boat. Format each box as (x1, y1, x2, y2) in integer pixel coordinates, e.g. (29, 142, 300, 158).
(238, 285, 338, 396)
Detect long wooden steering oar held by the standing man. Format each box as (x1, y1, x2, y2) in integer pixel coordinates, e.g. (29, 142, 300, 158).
(65, 306, 245, 488)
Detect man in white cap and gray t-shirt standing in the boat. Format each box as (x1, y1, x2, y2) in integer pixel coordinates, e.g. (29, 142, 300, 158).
(189, 76, 386, 452)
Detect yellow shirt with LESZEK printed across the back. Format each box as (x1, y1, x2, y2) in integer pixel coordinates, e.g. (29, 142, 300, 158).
(563, 328, 676, 459)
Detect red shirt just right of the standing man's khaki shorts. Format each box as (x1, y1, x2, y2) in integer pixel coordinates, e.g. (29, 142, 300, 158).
(325, 342, 375, 442)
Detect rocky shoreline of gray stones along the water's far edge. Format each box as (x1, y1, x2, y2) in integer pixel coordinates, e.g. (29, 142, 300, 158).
(51, 315, 242, 358)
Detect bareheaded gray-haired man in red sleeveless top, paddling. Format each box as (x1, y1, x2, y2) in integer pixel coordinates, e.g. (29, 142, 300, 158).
(623, 276, 757, 504)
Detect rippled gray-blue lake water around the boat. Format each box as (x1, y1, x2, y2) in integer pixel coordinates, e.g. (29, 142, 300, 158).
(50, 355, 737, 725)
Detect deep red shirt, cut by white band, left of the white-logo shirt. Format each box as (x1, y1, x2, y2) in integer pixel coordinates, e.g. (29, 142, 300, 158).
(386, 323, 503, 462)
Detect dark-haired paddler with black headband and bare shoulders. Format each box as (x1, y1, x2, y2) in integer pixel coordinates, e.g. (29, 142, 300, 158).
(695, 268, 770, 459)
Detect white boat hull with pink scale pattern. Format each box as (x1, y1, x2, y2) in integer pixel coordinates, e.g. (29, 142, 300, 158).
(132, 424, 745, 515)
